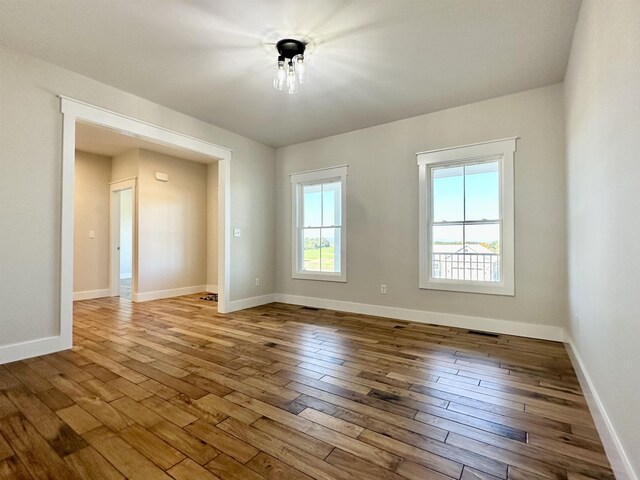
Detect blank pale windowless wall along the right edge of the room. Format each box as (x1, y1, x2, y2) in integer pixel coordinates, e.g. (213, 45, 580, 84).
(565, 0, 640, 478)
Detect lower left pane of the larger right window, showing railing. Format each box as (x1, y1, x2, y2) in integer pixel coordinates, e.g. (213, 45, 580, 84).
(431, 225, 464, 280)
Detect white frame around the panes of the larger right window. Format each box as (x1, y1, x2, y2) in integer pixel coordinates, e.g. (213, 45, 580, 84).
(416, 137, 518, 296)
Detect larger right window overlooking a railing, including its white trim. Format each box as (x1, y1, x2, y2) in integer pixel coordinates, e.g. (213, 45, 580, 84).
(417, 138, 516, 295)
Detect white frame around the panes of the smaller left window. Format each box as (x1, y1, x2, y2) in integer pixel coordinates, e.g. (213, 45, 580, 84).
(291, 165, 347, 282)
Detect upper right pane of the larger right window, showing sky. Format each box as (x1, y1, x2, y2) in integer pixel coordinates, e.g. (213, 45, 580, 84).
(464, 162, 500, 221)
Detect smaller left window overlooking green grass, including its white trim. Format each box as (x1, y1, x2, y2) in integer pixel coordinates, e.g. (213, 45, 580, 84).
(291, 166, 347, 282)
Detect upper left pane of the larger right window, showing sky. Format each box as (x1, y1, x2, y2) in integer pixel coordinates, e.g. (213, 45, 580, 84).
(431, 167, 464, 222)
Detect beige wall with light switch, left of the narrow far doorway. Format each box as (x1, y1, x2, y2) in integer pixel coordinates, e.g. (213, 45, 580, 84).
(73, 150, 111, 296)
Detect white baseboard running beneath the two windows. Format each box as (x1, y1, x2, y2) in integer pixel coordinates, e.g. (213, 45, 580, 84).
(275, 293, 564, 342)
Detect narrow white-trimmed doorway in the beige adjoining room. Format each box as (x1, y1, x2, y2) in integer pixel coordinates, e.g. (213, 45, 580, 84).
(109, 179, 136, 300)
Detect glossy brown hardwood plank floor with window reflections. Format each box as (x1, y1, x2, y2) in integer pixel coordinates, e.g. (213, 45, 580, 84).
(0, 295, 614, 480)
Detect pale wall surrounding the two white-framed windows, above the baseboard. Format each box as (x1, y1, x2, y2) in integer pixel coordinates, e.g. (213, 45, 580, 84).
(276, 85, 567, 332)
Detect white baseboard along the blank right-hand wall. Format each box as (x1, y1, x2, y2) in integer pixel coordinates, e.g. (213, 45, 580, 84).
(565, 335, 639, 480)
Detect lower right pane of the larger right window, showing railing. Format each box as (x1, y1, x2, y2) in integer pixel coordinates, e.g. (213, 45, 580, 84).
(464, 223, 500, 282)
